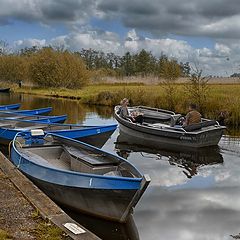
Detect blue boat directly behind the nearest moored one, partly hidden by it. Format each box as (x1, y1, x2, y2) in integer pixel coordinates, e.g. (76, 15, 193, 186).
(0, 119, 117, 147)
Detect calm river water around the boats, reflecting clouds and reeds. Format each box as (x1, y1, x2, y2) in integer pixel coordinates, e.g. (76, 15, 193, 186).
(0, 94, 240, 240)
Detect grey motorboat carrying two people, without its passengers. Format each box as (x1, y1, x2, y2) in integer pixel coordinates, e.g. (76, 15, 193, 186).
(114, 106, 226, 148)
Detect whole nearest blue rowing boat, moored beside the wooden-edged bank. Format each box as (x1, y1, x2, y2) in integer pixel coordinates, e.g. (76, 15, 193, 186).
(11, 130, 150, 222)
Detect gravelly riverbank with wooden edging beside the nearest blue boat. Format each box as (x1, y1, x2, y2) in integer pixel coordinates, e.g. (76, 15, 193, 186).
(0, 152, 99, 240)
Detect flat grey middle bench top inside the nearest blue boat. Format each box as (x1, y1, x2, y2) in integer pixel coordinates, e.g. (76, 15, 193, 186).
(65, 146, 114, 167)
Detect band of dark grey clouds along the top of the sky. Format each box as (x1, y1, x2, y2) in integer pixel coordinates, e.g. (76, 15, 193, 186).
(0, 0, 240, 39)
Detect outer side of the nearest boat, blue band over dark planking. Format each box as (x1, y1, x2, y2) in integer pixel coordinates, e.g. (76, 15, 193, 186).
(11, 144, 146, 222)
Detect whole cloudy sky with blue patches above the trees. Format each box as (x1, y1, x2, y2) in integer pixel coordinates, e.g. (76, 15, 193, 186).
(0, 0, 240, 76)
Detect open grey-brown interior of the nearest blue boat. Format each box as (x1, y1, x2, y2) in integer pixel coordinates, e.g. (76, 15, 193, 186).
(17, 135, 140, 178)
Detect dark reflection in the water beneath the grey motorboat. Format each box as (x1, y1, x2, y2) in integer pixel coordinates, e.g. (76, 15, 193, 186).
(115, 131, 223, 178)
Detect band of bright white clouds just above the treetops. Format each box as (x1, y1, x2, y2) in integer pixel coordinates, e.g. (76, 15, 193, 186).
(11, 29, 240, 75)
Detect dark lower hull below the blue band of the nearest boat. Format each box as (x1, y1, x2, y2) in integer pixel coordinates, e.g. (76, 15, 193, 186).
(27, 175, 137, 222)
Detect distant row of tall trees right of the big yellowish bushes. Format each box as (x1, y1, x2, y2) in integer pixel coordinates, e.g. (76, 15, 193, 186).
(76, 49, 191, 77)
